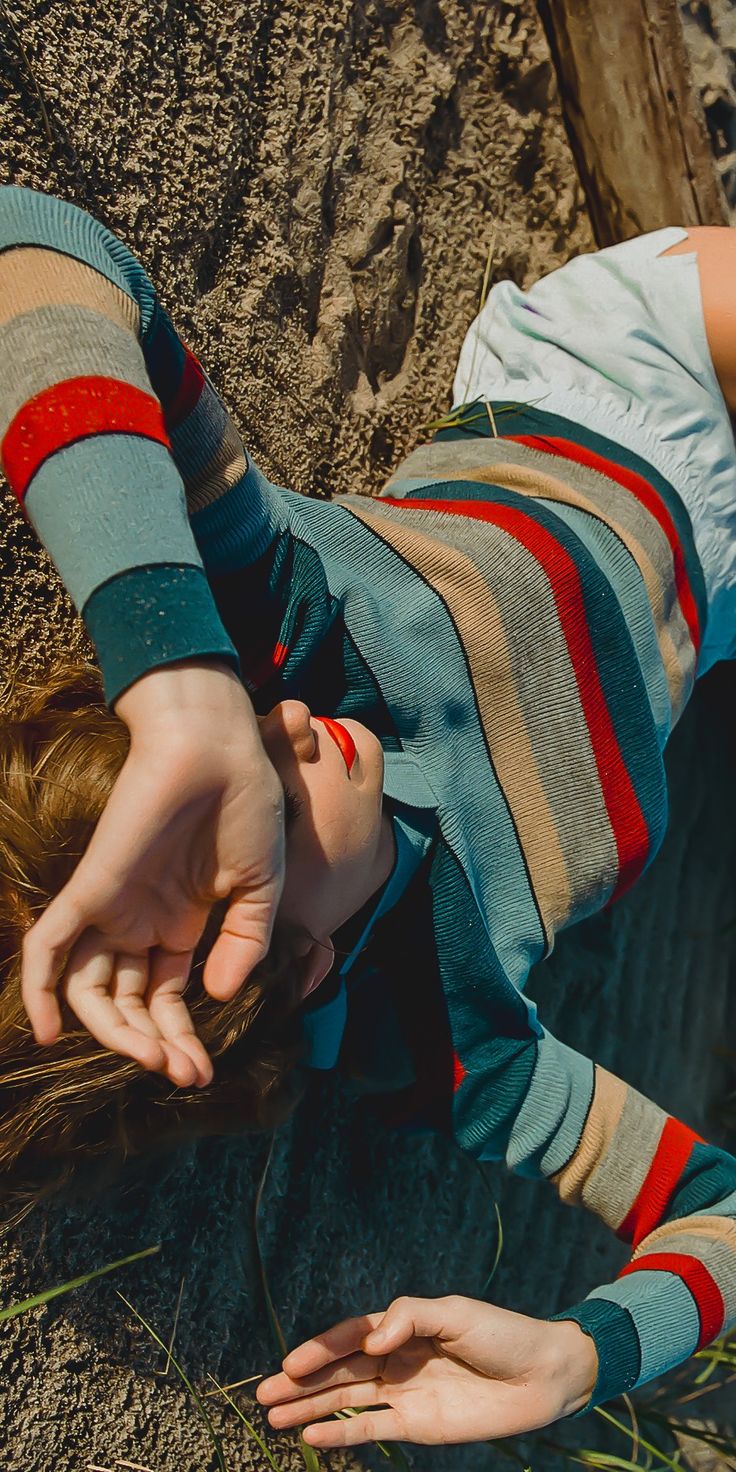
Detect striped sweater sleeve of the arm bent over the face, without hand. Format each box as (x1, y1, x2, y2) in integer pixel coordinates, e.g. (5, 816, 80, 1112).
(0, 185, 284, 704)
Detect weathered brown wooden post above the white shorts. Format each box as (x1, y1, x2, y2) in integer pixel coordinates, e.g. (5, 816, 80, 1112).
(537, 0, 729, 246)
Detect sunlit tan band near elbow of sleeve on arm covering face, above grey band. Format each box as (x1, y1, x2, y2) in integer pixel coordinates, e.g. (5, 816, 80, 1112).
(0, 246, 140, 337)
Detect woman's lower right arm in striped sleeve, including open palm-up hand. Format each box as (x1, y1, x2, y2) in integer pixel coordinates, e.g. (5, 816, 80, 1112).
(258, 1036, 736, 1448)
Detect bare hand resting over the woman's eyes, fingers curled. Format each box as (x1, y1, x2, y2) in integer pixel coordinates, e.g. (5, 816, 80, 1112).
(22, 661, 284, 1086)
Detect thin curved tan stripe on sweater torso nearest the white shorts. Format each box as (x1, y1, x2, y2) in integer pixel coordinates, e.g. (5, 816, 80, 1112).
(423, 462, 686, 715)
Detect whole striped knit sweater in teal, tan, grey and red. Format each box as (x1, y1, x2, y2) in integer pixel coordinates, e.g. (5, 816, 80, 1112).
(0, 187, 736, 1409)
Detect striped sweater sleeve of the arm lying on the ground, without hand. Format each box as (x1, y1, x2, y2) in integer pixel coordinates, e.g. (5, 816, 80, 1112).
(459, 1002, 736, 1410)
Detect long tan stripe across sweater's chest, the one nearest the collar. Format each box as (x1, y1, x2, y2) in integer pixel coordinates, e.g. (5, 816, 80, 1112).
(350, 502, 573, 944)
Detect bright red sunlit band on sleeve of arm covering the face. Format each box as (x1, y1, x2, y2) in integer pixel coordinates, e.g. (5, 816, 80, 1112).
(0, 375, 171, 505)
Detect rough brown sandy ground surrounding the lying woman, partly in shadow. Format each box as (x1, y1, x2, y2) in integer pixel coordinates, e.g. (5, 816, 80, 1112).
(0, 0, 736, 1472)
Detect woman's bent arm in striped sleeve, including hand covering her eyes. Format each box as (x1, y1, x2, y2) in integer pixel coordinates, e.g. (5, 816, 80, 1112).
(0, 187, 291, 1083)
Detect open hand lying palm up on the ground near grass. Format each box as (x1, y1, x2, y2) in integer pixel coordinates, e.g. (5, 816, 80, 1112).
(256, 1297, 598, 1448)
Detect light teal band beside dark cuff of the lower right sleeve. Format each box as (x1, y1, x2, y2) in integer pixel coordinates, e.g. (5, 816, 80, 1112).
(589, 1269, 701, 1385)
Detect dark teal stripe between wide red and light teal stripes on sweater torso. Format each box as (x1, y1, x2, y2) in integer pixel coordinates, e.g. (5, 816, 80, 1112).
(397, 481, 667, 863)
